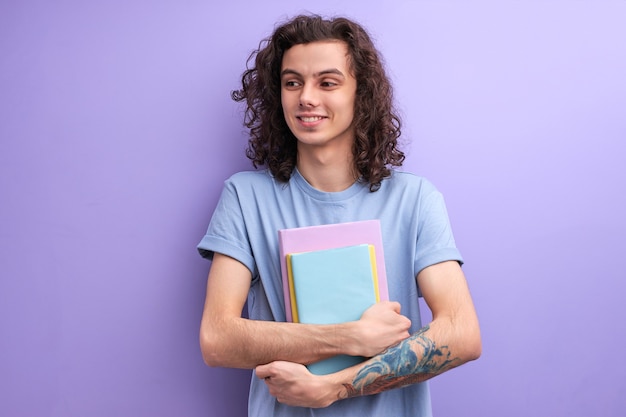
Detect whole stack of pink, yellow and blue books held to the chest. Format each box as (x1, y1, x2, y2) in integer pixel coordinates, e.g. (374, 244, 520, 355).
(278, 220, 389, 375)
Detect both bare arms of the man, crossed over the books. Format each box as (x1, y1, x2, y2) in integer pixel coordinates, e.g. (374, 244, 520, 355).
(200, 250, 481, 407)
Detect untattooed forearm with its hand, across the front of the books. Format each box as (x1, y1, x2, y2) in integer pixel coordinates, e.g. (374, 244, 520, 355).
(200, 302, 411, 368)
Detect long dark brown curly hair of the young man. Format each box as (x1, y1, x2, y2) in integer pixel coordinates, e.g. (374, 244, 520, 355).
(231, 15, 404, 191)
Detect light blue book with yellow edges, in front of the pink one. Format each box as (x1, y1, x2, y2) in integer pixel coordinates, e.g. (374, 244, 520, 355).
(287, 244, 380, 375)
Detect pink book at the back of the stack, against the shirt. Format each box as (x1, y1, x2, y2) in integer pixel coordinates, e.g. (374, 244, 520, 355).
(278, 220, 389, 321)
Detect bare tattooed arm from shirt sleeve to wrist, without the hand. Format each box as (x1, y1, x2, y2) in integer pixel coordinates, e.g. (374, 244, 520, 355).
(339, 261, 481, 398)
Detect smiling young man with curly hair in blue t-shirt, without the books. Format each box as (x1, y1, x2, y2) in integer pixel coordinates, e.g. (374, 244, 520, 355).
(199, 16, 481, 417)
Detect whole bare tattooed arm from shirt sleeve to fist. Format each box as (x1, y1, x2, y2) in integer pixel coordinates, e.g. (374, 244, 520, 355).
(257, 261, 481, 407)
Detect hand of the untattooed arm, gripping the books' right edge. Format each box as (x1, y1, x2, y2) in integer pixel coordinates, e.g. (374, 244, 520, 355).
(350, 301, 411, 358)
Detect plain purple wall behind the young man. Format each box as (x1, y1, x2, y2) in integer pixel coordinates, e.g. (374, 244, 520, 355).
(0, 0, 626, 417)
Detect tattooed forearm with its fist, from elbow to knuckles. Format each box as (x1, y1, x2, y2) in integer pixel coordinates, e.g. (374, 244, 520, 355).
(256, 316, 480, 408)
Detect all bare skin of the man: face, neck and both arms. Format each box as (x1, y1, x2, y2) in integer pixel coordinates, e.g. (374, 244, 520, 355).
(200, 41, 481, 407)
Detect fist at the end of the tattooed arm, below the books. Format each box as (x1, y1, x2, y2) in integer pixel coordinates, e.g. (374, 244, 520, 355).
(256, 361, 338, 408)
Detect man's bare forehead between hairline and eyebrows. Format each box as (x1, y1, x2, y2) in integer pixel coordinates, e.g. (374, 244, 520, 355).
(281, 41, 350, 74)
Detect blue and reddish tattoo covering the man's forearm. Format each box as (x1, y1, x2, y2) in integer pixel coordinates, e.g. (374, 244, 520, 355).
(344, 326, 459, 398)
